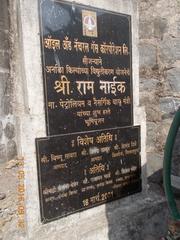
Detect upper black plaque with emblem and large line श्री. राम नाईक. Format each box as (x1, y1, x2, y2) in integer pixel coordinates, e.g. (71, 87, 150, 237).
(39, 0, 133, 135)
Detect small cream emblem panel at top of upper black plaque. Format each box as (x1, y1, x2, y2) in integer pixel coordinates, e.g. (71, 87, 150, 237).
(82, 10, 97, 37)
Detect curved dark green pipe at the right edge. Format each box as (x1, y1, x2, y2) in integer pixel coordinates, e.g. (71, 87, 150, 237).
(163, 110, 180, 221)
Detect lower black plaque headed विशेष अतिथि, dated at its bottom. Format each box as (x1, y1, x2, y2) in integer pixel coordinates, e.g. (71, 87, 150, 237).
(36, 126, 141, 223)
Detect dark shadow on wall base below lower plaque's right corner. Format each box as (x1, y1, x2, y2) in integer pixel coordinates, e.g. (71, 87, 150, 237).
(106, 166, 169, 240)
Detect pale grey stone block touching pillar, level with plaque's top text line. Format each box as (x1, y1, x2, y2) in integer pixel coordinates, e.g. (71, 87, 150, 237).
(139, 43, 157, 68)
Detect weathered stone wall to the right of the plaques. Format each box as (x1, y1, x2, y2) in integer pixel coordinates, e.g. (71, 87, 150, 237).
(139, 0, 180, 176)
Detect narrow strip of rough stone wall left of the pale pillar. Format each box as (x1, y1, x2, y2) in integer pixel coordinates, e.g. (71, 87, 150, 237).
(0, 0, 17, 163)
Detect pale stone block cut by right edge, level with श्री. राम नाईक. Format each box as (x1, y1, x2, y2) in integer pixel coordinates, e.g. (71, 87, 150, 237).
(167, 68, 180, 93)
